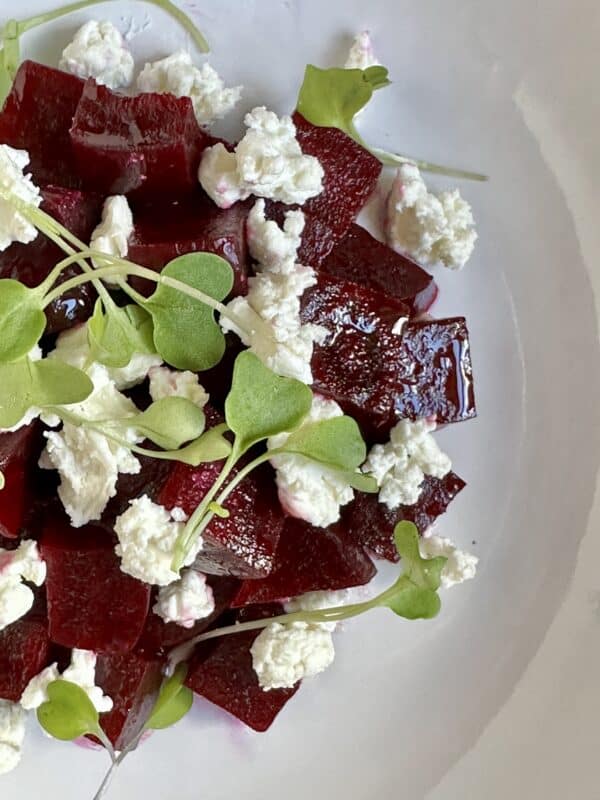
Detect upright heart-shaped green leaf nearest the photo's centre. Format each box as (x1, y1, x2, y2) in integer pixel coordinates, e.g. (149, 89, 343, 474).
(225, 351, 312, 455)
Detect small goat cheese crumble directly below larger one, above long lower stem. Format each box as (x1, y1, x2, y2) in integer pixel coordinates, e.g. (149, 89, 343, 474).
(152, 569, 215, 628)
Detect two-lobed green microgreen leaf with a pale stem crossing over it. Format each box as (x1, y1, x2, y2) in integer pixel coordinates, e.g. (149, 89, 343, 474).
(145, 253, 233, 372)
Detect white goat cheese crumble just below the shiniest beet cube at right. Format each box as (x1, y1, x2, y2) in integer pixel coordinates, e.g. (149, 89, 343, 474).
(362, 419, 452, 511)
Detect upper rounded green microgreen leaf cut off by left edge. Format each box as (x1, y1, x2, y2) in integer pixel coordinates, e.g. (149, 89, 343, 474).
(0, 278, 46, 362)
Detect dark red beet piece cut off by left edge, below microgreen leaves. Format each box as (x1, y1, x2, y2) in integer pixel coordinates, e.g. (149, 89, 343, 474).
(0, 423, 42, 538)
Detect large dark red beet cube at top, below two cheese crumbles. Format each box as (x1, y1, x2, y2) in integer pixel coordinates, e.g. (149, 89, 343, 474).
(71, 79, 210, 196)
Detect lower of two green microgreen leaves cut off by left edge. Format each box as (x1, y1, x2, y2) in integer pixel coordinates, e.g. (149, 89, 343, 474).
(0, 358, 94, 428)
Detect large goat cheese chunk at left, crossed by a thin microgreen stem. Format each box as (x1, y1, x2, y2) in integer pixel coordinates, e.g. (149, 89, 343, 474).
(39, 364, 143, 528)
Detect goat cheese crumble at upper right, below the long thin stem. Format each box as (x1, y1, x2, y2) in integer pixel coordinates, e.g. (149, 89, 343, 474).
(386, 164, 477, 269)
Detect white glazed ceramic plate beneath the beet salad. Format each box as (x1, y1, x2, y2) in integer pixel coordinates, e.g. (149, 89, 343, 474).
(0, 0, 600, 800)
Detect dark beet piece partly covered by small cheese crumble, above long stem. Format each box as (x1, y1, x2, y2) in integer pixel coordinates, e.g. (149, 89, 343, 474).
(135, 575, 240, 657)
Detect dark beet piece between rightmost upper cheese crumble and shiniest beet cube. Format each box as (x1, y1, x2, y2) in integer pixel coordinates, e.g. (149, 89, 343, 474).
(321, 225, 438, 316)
